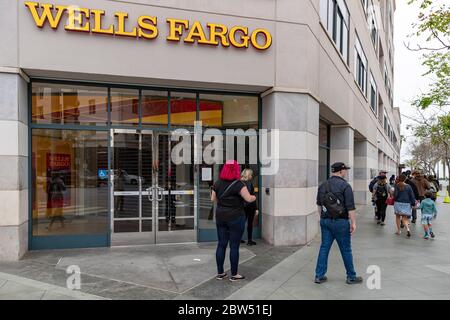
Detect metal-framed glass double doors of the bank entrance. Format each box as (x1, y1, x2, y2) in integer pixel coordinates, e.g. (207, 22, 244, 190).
(111, 130, 197, 245)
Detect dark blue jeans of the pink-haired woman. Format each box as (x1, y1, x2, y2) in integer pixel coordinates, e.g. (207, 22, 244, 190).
(216, 215, 245, 276)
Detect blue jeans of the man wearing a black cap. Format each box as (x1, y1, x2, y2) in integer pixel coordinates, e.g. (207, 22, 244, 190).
(316, 219, 356, 279)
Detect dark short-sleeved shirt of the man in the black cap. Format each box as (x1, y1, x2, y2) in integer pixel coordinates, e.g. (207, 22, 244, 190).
(316, 176, 355, 219)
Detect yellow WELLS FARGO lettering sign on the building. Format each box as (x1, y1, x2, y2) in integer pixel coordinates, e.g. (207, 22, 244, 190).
(25, 1, 272, 50)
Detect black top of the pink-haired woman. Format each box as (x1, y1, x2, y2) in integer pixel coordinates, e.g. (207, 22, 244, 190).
(213, 180, 245, 221)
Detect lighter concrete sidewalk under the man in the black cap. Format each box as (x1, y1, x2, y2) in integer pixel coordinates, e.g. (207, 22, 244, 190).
(228, 198, 450, 300)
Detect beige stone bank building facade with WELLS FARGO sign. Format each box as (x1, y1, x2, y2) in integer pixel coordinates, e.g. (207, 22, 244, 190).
(0, 0, 400, 260)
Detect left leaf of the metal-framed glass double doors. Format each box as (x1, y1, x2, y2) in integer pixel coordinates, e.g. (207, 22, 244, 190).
(111, 129, 155, 245)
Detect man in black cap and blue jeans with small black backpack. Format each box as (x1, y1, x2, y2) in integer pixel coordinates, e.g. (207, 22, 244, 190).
(314, 162, 363, 284)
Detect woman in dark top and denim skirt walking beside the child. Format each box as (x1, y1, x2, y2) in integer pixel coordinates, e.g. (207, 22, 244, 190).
(394, 174, 416, 238)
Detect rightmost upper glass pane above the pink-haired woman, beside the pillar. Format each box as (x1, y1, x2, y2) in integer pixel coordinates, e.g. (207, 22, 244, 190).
(200, 94, 258, 130)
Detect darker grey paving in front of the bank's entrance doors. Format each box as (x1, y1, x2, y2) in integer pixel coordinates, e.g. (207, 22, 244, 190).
(0, 241, 300, 300)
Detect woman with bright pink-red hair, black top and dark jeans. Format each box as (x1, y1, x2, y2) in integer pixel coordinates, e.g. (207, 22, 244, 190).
(211, 160, 256, 281)
